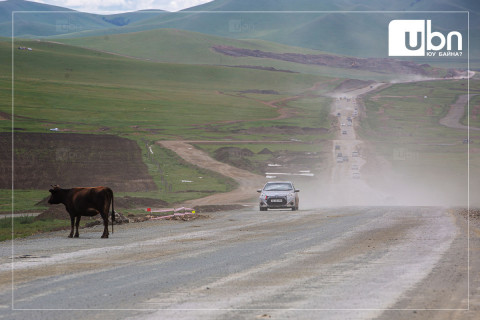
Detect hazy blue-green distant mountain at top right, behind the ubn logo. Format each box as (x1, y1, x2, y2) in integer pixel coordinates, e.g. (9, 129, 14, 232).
(185, 0, 480, 57)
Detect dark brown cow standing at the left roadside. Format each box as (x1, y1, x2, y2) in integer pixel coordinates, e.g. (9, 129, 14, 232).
(48, 186, 115, 238)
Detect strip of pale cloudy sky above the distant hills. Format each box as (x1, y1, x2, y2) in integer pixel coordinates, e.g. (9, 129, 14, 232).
(25, 0, 212, 13)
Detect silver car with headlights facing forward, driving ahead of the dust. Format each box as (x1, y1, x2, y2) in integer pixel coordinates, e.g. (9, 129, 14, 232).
(257, 181, 300, 211)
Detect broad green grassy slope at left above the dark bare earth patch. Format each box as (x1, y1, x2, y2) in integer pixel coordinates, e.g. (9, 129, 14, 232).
(0, 38, 342, 138)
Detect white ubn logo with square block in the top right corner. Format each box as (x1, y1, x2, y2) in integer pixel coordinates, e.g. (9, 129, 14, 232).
(388, 20, 462, 57)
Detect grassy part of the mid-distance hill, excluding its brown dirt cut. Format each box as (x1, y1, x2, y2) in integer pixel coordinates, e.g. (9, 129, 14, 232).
(56, 29, 442, 81)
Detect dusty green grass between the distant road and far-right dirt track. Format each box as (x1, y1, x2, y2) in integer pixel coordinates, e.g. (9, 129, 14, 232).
(360, 80, 467, 144)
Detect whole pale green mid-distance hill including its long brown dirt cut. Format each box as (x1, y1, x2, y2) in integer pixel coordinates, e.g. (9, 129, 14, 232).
(56, 29, 454, 81)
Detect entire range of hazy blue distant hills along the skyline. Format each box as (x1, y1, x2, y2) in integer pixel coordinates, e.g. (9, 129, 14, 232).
(0, 0, 480, 63)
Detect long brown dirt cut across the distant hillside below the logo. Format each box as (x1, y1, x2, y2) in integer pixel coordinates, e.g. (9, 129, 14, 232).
(212, 45, 458, 77)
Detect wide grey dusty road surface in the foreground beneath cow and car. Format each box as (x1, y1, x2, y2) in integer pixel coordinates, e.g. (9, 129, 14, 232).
(0, 207, 472, 320)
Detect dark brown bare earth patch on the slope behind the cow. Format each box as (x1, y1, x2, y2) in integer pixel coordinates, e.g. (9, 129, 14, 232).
(0, 132, 157, 192)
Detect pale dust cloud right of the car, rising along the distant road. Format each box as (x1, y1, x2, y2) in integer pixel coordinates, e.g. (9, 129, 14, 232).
(297, 77, 472, 209)
